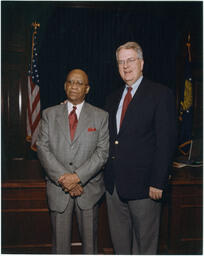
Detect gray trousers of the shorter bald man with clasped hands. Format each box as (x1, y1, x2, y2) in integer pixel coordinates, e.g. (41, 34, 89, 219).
(51, 199, 98, 254)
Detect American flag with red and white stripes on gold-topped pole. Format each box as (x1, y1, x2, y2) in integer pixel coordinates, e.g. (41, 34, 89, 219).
(26, 22, 40, 151)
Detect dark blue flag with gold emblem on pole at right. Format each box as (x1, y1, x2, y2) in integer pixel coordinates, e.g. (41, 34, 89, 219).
(179, 35, 193, 155)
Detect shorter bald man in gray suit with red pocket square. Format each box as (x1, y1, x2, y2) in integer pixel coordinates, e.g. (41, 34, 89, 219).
(37, 69, 109, 254)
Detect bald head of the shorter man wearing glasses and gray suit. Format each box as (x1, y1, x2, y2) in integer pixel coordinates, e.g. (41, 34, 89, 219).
(65, 69, 90, 105)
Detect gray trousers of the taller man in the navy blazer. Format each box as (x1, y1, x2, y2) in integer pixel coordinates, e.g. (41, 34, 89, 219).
(106, 189, 161, 255)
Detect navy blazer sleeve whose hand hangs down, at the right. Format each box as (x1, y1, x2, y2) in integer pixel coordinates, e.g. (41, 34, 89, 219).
(150, 90, 177, 189)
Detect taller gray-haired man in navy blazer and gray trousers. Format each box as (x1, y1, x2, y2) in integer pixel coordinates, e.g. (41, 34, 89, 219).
(105, 42, 177, 254)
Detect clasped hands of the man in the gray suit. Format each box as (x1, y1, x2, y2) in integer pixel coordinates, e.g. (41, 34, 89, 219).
(58, 173, 80, 192)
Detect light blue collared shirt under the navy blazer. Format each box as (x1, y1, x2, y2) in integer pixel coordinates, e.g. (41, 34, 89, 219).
(116, 76, 143, 133)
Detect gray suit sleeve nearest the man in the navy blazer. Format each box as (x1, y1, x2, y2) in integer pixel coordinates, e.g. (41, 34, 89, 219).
(75, 113, 109, 185)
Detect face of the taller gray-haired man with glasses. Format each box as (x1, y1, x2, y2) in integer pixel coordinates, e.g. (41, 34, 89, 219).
(117, 49, 144, 86)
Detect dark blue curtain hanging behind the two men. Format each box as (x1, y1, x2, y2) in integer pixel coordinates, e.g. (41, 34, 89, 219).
(40, 4, 178, 109)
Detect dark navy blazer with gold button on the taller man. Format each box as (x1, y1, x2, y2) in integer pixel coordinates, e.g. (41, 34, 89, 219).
(104, 78, 177, 200)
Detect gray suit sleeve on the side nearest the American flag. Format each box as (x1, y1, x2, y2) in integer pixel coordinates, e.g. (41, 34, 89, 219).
(36, 111, 67, 185)
